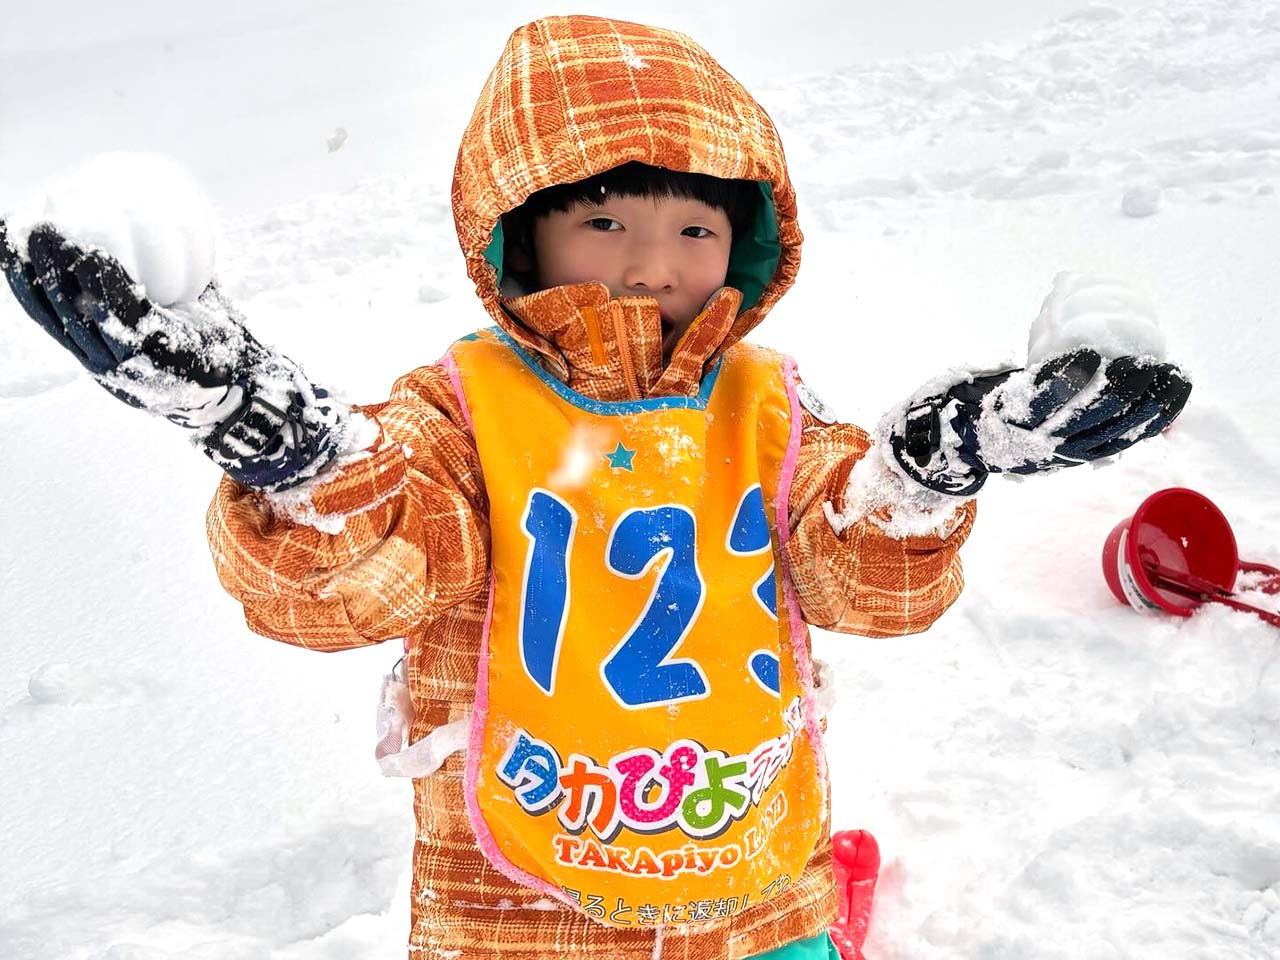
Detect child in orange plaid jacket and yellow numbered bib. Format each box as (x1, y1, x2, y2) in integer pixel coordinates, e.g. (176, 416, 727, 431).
(0, 17, 1189, 960)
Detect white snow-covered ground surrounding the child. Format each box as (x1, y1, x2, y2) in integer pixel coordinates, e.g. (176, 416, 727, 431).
(0, 0, 1280, 960)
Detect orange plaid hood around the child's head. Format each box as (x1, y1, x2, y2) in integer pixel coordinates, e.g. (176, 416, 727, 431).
(453, 17, 803, 368)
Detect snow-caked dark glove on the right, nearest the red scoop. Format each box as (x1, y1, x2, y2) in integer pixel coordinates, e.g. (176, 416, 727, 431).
(876, 347, 1192, 497)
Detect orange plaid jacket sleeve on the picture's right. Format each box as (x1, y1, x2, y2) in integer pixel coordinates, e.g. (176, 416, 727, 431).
(787, 411, 974, 636)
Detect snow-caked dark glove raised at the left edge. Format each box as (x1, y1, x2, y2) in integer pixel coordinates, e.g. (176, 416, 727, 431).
(0, 221, 367, 492)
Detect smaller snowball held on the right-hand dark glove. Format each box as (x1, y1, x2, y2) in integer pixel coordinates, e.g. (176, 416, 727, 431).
(1027, 273, 1165, 365)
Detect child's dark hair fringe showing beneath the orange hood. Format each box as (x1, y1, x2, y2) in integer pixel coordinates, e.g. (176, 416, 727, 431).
(502, 161, 760, 288)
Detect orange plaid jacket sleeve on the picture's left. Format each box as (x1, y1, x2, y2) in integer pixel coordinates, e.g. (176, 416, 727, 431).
(206, 366, 488, 650)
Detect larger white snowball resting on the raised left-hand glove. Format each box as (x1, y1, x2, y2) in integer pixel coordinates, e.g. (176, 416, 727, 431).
(9, 152, 214, 306)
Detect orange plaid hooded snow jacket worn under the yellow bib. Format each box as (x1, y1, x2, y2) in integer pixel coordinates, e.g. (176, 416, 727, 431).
(207, 17, 973, 960)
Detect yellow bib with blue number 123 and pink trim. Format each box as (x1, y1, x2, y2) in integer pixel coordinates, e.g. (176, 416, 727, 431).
(445, 332, 826, 927)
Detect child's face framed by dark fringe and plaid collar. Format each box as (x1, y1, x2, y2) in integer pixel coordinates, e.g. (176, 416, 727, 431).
(534, 196, 733, 356)
